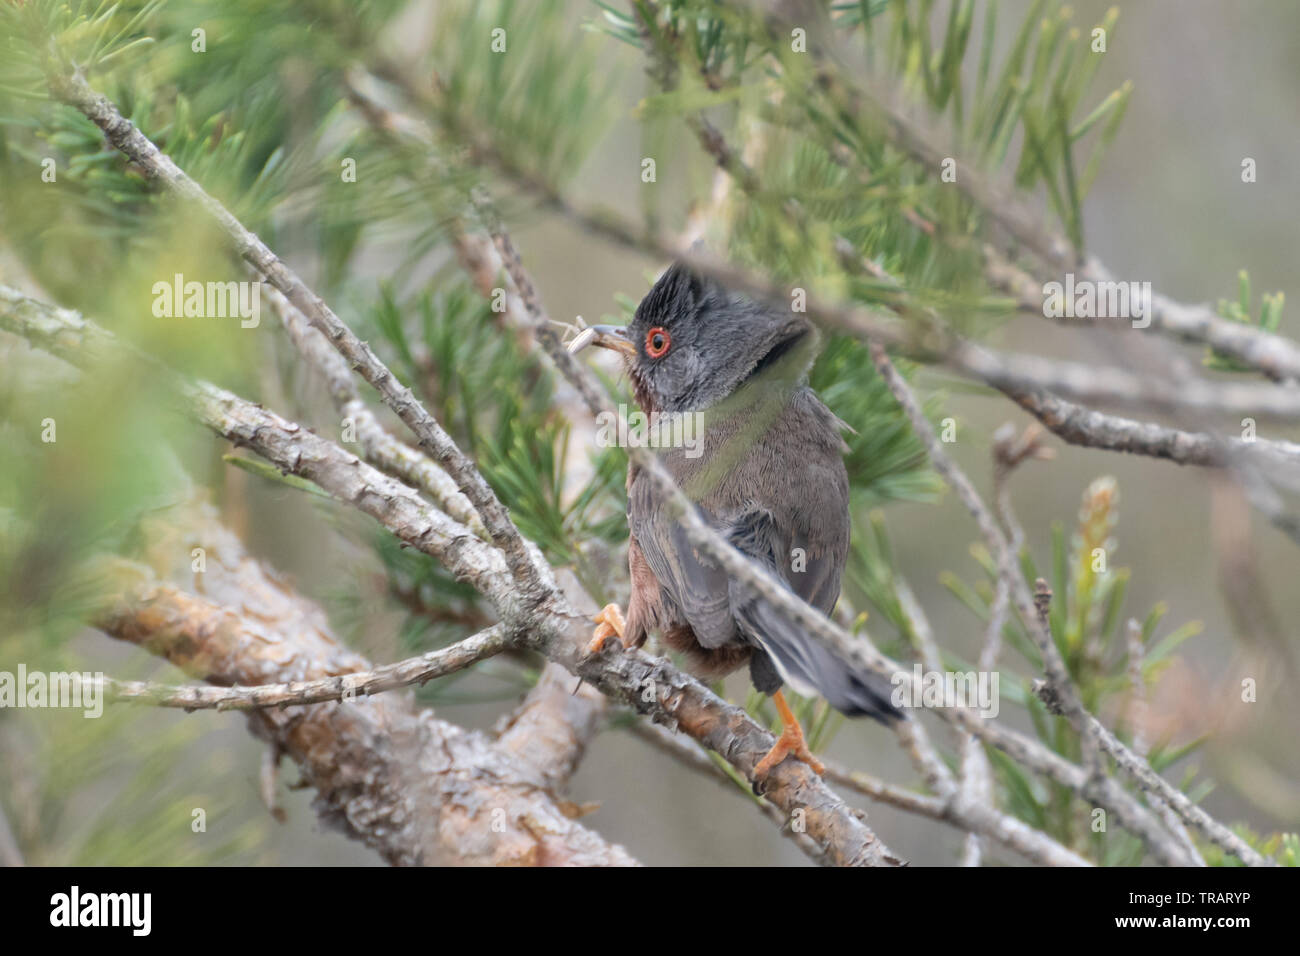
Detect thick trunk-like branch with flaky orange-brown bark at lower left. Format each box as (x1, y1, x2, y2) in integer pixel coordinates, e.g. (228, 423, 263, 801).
(98, 512, 636, 866)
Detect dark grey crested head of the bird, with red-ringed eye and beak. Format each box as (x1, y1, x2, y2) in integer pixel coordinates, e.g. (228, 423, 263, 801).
(571, 264, 813, 412)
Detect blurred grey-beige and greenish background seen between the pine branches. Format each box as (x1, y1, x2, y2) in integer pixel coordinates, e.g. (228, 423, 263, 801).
(0, 0, 1300, 865)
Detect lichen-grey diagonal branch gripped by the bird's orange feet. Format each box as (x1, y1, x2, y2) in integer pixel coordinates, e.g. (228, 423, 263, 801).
(0, 287, 900, 866)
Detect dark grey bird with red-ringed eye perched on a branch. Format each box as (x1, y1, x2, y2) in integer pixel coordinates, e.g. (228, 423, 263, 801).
(571, 264, 898, 777)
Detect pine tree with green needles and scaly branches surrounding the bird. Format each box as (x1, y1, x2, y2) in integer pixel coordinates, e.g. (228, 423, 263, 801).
(0, 0, 1300, 865)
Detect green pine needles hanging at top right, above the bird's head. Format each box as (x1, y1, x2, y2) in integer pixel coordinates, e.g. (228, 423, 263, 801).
(592, 0, 1131, 306)
